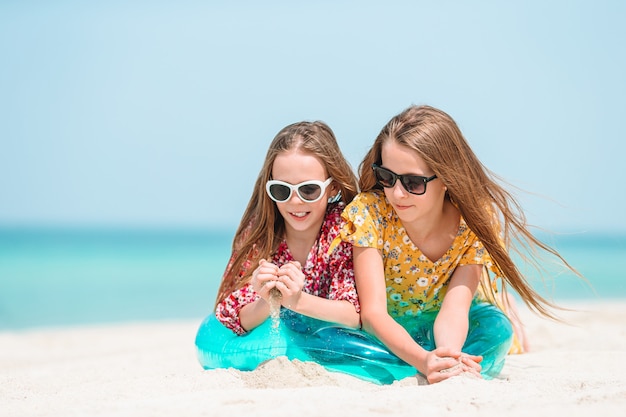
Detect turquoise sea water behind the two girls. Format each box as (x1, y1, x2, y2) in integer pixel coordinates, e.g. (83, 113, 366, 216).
(0, 228, 626, 330)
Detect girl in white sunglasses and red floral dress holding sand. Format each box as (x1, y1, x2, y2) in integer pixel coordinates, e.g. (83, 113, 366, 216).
(210, 121, 359, 335)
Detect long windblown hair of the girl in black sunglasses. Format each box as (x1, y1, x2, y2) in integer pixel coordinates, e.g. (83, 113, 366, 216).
(359, 106, 580, 319)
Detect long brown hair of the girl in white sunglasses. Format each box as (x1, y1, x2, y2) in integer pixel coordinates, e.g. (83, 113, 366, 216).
(216, 121, 358, 305)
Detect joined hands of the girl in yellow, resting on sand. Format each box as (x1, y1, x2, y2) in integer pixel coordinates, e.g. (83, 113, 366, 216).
(426, 348, 483, 384)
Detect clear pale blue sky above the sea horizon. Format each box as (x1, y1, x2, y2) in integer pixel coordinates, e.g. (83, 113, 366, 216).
(0, 0, 626, 233)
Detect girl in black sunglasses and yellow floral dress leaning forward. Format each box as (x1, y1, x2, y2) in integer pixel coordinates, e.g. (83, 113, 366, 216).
(342, 106, 575, 383)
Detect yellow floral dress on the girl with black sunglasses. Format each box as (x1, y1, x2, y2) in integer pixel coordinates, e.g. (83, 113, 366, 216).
(341, 190, 521, 353)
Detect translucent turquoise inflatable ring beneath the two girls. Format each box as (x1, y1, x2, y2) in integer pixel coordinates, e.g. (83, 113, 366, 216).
(195, 304, 512, 384)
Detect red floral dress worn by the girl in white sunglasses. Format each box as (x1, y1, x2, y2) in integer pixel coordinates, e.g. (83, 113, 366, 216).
(215, 203, 360, 335)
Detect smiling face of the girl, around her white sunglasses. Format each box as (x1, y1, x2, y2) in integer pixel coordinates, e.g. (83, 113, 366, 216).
(272, 151, 334, 239)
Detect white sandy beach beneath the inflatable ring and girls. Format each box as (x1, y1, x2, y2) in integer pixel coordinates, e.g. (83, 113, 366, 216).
(0, 300, 626, 417)
